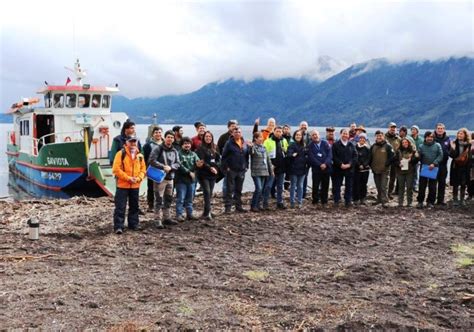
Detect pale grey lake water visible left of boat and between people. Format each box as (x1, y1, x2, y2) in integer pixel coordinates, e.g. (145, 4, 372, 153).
(0, 123, 456, 199)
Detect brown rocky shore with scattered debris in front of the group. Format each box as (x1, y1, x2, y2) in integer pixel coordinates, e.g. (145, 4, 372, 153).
(0, 188, 474, 331)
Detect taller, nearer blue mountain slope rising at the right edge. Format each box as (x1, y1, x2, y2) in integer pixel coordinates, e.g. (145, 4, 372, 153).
(292, 57, 474, 129)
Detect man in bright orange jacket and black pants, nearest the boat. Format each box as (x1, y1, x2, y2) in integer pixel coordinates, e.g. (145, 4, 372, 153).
(112, 136, 146, 234)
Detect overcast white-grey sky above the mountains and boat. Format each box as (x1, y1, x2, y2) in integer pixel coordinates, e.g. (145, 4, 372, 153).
(0, 0, 474, 109)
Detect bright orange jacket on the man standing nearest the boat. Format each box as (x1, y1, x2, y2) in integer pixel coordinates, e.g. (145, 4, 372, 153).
(112, 147, 146, 189)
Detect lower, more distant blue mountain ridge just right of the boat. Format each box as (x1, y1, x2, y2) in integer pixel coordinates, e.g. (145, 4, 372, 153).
(112, 78, 318, 124)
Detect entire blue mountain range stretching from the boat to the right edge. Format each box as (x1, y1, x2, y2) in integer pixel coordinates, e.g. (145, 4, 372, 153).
(113, 57, 474, 129)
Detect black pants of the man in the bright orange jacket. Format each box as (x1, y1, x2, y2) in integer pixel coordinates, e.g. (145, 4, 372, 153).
(114, 188, 140, 230)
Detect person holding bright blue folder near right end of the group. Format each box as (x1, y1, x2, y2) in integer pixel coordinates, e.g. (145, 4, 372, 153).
(417, 131, 443, 209)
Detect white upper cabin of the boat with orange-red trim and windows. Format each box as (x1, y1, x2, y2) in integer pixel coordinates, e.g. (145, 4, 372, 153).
(10, 84, 127, 160)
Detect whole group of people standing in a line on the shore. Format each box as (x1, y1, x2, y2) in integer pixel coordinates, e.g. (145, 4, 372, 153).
(111, 118, 474, 234)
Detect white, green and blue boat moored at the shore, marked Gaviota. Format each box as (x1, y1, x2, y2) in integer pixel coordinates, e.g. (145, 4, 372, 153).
(6, 60, 139, 196)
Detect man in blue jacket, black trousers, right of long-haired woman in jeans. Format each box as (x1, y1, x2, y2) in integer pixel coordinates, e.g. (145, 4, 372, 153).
(308, 130, 332, 206)
